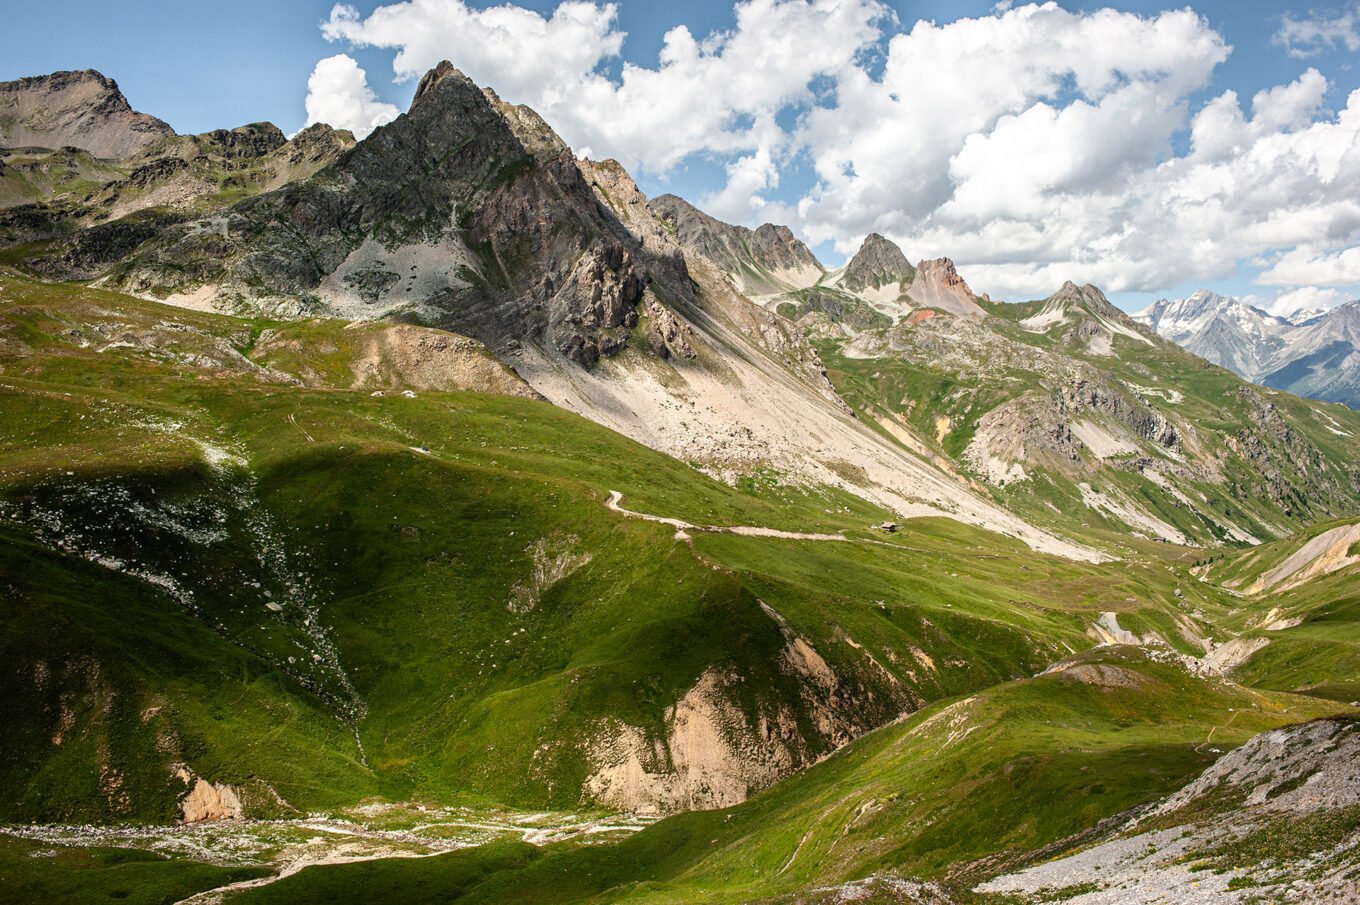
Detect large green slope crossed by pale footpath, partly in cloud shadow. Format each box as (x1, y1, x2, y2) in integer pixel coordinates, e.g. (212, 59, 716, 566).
(0, 266, 1219, 819)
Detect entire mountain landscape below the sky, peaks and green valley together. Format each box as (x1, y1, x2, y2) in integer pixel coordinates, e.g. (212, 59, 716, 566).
(0, 63, 1360, 905)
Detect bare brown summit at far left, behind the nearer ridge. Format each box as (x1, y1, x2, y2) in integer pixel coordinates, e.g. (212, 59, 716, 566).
(0, 69, 174, 158)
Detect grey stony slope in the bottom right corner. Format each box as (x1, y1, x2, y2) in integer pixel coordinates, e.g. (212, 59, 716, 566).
(978, 720, 1360, 905)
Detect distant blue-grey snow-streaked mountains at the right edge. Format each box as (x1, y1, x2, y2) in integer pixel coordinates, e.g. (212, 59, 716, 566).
(1133, 290, 1360, 408)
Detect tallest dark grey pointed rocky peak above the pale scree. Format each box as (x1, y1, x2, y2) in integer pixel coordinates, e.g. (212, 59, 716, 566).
(113, 63, 658, 366)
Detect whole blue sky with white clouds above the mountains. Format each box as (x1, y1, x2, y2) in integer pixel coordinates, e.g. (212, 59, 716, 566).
(0, 0, 1360, 309)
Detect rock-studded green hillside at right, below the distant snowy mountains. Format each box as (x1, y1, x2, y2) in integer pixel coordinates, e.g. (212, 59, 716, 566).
(819, 296, 1360, 548)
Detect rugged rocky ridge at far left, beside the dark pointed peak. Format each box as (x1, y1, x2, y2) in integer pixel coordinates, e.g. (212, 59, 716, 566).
(0, 71, 354, 279)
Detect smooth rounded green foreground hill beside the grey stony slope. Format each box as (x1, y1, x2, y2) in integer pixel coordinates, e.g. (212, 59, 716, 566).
(225, 648, 1336, 904)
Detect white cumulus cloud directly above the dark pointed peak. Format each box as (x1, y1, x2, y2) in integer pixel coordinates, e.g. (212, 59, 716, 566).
(322, 0, 891, 184)
